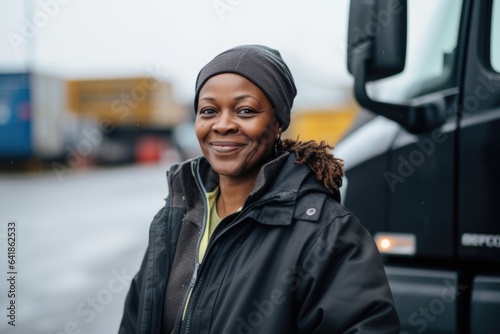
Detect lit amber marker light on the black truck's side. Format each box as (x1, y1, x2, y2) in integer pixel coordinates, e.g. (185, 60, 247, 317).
(374, 232, 417, 255)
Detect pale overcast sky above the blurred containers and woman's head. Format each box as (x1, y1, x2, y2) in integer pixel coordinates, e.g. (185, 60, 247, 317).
(0, 0, 351, 105)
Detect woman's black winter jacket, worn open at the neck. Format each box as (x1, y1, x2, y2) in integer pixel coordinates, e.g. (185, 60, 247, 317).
(120, 153, 399, 334)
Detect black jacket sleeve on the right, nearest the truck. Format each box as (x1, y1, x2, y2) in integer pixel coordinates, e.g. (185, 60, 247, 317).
(296, 214, 399, 334)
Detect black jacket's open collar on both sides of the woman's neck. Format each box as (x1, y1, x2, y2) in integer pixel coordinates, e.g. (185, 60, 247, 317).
(170, 152, 334, 227)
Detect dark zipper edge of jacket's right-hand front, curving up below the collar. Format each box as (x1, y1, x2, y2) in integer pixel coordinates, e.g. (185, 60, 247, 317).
(184, 195, 279, 334)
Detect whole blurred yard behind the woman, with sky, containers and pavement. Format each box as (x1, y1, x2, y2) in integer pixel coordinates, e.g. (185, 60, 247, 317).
(0, 0, 358, 334)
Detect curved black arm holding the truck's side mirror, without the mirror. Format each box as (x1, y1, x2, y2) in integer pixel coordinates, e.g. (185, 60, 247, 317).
(352, 46, 444, 133)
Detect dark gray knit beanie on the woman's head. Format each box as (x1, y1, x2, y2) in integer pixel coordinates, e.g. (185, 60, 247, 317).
(194, 45, 297, 131)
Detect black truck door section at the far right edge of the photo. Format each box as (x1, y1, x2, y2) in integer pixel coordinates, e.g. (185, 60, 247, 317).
(456, 0, 500, 333)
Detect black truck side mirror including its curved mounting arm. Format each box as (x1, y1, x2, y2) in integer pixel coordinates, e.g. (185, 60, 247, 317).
(347, 0, 444, 133)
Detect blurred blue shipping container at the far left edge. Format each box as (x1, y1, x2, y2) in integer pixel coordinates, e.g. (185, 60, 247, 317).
(0, 73, 32, 158)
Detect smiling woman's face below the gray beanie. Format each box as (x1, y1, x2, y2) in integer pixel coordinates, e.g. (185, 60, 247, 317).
(195, 73, 281, 183)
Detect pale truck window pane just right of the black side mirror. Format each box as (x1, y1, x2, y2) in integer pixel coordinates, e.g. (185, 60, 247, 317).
(367, 0, 462, 103)
